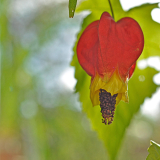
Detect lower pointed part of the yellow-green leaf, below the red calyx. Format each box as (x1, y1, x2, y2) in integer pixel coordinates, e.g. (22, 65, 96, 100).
(72, 58, 157, 159)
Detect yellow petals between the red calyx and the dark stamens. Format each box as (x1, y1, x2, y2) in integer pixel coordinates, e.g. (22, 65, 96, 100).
(90, 70, 128, 106)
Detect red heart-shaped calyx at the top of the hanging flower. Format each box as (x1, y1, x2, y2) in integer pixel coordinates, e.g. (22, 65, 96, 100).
(77, 12, 144, 81)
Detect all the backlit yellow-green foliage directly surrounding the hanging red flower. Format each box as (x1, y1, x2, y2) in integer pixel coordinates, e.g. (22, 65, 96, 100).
(72, 0, 160, 160)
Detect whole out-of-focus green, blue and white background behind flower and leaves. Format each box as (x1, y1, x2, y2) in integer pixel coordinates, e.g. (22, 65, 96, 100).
(0, 0, 160, 160)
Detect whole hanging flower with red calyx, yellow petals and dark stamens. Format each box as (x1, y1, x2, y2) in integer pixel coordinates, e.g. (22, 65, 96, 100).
(77, 12, 144, 124)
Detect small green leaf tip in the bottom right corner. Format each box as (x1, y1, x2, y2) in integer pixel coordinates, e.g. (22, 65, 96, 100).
(146, 141, 160, 160)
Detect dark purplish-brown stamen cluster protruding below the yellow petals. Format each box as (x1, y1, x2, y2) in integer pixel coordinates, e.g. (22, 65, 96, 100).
(99, 89, 118, 125)
